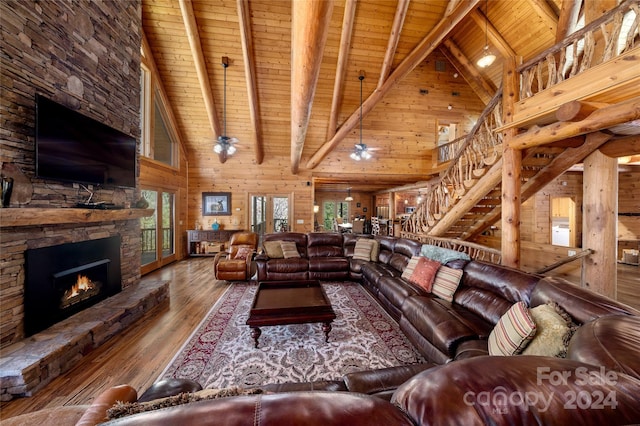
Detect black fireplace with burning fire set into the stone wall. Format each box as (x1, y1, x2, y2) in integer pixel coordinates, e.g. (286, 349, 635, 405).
(24, 236, 122, 336)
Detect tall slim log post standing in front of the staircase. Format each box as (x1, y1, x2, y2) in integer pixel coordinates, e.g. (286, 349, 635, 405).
(501, 56, 522, 268)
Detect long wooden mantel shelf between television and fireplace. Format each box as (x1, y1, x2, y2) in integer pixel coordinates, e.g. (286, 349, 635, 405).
(0, 207, 155, 228)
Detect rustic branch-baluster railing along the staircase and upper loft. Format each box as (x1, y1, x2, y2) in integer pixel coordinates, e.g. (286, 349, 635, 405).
(401, 0, 640, 253)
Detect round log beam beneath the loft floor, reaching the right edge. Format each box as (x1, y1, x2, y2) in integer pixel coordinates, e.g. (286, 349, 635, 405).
(509, 97, 640, 149)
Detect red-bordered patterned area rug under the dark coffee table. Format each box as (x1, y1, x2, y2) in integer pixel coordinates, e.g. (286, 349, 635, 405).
(159, 282, 424, 388)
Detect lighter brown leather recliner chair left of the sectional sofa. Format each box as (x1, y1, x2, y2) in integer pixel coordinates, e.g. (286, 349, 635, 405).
(213, 232, 258, 281)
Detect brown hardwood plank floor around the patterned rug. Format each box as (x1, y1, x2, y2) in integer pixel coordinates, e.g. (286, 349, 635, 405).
(0, 258, 640, 419)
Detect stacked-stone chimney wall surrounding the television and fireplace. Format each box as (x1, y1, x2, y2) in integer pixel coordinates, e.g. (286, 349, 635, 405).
(0, 0, 142, 348)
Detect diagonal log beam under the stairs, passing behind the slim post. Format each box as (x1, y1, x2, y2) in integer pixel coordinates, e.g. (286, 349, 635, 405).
(468, 133, 611, 239)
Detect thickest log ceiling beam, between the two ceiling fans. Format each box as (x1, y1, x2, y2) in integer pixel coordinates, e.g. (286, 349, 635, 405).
(291, 0, 333, 174)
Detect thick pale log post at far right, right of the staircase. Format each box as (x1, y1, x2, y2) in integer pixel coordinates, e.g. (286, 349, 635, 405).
(581, 151, 618, 299)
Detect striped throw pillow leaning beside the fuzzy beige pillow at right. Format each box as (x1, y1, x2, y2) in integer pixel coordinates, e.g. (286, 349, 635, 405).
(489, 302, 536, 356)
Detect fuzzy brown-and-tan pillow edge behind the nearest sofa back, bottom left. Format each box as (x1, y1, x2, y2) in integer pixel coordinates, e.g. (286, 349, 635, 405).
(107, 388, 263, 420)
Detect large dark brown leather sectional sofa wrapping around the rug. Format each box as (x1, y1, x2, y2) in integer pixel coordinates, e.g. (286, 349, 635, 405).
(15, 233, 640, 426)
